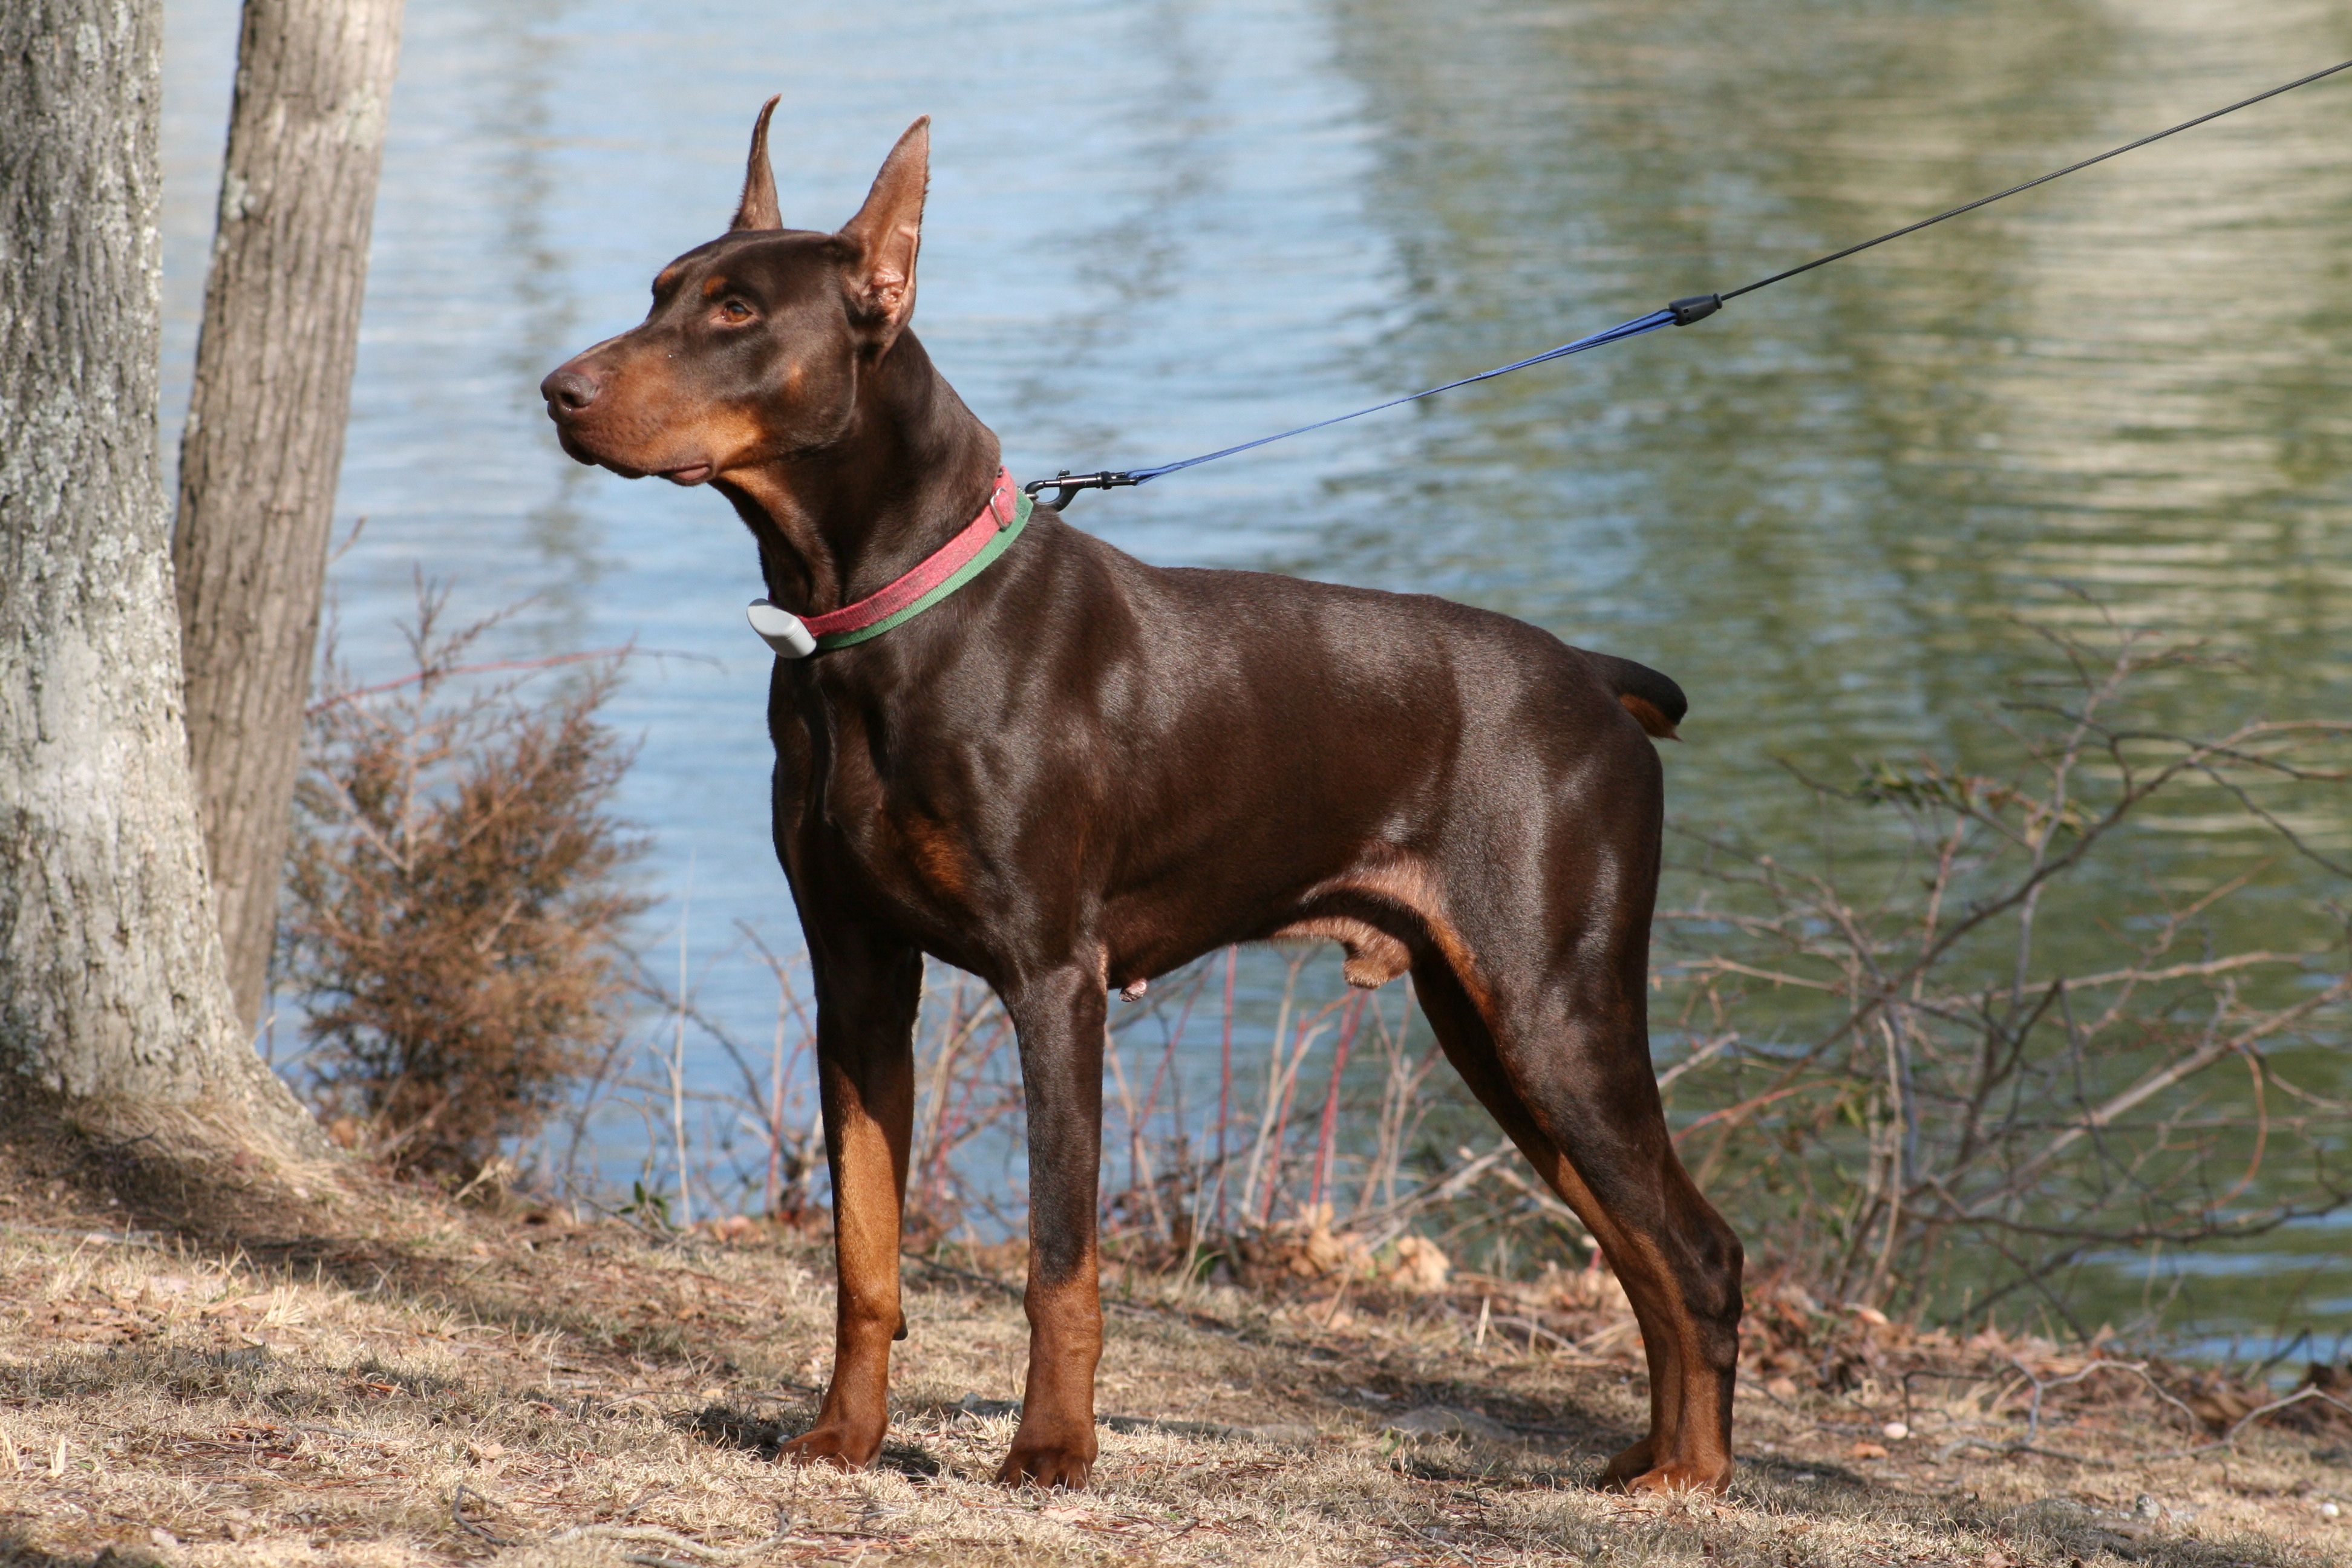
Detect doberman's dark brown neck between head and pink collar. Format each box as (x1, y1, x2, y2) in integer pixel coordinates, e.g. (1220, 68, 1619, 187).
(715, 332, 1002, 616)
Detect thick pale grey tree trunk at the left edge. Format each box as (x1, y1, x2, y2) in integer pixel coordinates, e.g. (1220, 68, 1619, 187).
(0, 0, 308, 1133)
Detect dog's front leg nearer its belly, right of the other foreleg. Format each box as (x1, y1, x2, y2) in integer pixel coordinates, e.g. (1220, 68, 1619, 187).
(998, 966, 1108, 1486)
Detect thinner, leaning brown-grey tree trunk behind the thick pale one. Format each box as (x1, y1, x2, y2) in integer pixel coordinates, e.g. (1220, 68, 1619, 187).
(172, 0, 400, 1032)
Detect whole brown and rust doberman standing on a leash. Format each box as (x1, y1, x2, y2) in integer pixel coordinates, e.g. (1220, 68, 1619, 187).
(541, 99, 1740, 1488)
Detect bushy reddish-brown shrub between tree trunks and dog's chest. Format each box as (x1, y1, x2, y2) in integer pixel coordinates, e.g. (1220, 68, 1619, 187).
(280, 583, 647, 1178)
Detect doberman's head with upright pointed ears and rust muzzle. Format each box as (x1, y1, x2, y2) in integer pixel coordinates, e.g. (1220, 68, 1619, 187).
(538, 99, 932, 485)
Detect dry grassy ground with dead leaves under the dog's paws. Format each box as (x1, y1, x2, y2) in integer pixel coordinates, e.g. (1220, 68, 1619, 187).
(0, 1117, 2352, 1568)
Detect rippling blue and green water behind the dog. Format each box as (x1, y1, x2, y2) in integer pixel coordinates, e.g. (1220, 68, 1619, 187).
(165, 0, 2352, 1333)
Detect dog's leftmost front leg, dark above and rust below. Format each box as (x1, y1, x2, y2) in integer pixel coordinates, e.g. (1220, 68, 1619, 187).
(783, 929, 922, 1469)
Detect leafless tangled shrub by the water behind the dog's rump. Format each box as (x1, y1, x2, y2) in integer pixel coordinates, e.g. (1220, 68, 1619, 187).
(1661, 623, 2352, 1333)
